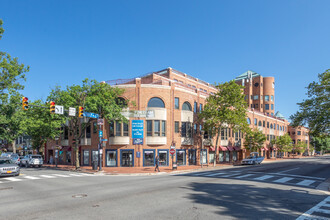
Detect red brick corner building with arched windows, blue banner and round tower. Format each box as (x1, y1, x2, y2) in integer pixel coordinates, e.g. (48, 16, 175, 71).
(45, 68, 310, 167)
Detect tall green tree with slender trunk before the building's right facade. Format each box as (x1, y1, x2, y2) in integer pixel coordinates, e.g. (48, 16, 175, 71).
(199, 80, 248, 166)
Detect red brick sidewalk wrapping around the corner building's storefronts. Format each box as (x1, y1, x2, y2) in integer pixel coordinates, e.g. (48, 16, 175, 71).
(43, 164, 233, 175)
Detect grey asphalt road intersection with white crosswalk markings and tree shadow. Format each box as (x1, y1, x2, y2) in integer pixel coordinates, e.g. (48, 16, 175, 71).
(0, 157, 330, 220)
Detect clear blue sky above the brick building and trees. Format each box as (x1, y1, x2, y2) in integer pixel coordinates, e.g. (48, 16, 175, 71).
(0, 0, 330, 118)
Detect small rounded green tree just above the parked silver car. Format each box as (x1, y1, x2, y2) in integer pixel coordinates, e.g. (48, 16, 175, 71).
(244, 128, 266, 152)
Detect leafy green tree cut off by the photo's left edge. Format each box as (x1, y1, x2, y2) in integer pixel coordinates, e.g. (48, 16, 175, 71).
(0, 20, 29, 152)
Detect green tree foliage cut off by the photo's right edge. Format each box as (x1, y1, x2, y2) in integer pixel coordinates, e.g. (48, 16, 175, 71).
(290, 70, 330, 137)
